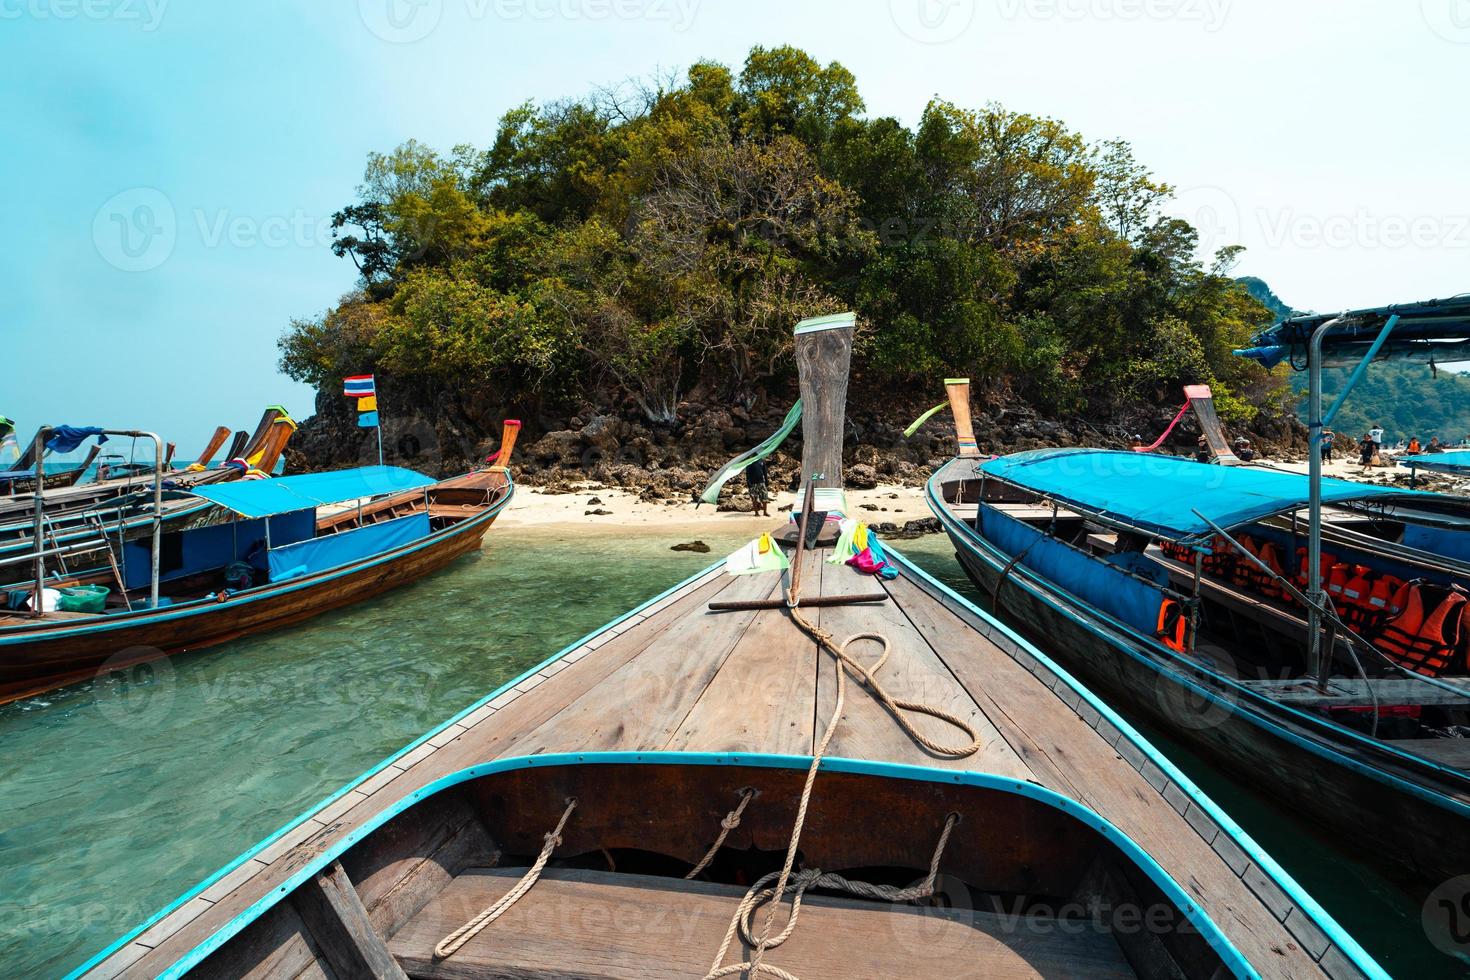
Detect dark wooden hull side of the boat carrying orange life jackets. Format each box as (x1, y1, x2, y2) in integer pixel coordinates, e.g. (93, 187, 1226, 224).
(929, 478, 1470, 895)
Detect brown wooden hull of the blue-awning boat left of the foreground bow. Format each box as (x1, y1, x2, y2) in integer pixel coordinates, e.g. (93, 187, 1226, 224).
(0, 495, 509, 704)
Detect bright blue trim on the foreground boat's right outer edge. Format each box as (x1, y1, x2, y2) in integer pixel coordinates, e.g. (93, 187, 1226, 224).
(917, 478, 1389, 980)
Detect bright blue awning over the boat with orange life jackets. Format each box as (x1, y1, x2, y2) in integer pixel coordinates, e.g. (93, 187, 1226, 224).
(979, 450, 1442, 541)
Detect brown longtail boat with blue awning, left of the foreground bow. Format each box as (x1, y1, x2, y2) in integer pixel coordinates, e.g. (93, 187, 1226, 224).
(0, 423, 519, 702)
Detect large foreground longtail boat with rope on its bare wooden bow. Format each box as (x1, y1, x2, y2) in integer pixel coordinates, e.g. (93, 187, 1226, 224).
(69, 319, 1383, 980)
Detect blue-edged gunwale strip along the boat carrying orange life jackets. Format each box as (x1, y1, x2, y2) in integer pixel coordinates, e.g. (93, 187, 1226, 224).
(929, 473, 1470, 799)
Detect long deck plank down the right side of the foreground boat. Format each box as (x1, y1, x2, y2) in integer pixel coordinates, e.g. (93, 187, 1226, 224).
(889, 579, 1322, 977)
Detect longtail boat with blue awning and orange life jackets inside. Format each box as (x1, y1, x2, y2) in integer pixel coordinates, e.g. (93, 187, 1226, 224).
(929, 434, 1470, 896)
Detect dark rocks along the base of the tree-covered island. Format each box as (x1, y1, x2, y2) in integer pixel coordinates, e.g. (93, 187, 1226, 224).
(288, 385, 1305, 510)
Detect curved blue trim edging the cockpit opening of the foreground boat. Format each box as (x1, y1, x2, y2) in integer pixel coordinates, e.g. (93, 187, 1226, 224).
(103, 752, 1260, 980)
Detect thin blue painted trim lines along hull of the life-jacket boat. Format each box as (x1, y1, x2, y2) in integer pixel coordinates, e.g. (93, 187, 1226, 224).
(931, 476, 1470, 818)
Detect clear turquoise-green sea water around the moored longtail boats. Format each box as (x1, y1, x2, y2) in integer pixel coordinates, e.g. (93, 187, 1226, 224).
(0, 526, 1458, 976)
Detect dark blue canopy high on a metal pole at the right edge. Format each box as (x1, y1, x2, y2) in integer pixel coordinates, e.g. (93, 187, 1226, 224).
(1235, 295, 1470, 367)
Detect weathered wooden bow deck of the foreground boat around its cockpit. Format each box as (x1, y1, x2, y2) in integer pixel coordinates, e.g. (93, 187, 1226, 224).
(88, 551, 1361, 977)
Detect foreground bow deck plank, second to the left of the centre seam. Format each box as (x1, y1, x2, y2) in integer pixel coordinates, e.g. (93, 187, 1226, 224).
(510, 574, 779, 755)
